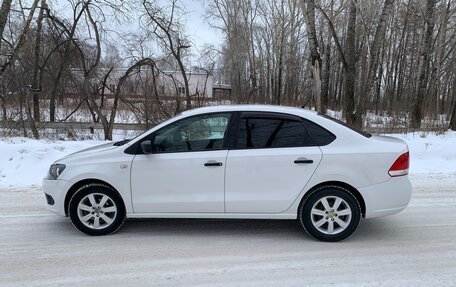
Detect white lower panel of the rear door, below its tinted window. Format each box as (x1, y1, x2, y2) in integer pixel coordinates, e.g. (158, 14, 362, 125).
(225, 147, 322, 213)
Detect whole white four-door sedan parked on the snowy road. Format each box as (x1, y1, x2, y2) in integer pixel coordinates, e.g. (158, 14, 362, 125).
(43, 105, 412, 241)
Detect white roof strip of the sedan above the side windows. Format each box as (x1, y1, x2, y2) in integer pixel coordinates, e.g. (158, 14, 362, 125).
(182, 105, 317, 115)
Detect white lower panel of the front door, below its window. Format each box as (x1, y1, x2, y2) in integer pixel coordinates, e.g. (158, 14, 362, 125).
(131, 150, 228, 213)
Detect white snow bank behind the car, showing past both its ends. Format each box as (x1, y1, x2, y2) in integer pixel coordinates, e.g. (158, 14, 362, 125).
(0, 132, 456, 188)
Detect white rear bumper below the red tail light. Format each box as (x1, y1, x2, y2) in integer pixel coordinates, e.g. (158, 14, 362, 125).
(358, 176, 412, 218)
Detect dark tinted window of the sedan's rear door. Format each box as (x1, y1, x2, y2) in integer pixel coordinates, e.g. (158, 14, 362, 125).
(236, 117, 315, 149)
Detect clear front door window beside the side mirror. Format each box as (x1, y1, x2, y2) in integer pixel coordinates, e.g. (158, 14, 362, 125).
(153, 113, 231, 152)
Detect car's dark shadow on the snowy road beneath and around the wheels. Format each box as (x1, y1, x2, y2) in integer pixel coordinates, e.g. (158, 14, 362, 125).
(49, 216, 414, 243)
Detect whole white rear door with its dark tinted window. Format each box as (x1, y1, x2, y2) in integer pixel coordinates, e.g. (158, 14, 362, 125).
(225, 112, 322, 213)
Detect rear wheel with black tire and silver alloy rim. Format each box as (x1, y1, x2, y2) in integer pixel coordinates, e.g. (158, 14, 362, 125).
(298, 186, 361, 242)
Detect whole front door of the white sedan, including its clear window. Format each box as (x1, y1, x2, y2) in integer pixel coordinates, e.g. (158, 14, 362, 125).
(131, 113, 231, 213)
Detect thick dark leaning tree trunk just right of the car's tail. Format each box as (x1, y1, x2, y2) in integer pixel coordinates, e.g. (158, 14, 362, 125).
(411, 0, 435, 128)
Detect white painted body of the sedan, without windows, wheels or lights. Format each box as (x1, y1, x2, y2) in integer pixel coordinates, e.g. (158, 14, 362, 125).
(43, 105, 411, 222)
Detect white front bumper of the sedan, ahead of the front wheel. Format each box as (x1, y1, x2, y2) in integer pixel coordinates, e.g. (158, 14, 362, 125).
(43, 178, 72, 216)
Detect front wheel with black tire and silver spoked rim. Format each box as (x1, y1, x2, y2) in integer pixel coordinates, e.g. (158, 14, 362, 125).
(68, 183, 126, 235)
